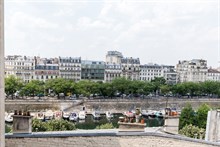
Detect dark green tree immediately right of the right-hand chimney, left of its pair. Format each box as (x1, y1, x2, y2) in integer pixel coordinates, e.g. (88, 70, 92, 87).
(179, 103, 195, 130)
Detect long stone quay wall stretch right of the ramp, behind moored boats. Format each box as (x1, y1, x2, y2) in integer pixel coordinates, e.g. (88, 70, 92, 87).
(84, 98, 220, 112)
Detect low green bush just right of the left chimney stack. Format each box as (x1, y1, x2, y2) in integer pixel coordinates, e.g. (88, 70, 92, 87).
(32, 119, 76, 132)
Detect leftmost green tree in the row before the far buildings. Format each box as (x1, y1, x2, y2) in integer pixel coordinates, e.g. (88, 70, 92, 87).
(5, 76, 23, 98)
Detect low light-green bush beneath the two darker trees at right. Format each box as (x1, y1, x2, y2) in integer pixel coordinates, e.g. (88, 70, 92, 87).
(179, 124, 205, 139)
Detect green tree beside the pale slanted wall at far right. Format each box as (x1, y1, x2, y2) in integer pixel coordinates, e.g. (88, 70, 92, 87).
(195, 104, 211, 129)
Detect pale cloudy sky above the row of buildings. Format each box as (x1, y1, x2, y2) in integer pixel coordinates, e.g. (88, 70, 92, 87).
(5, 0, 220, 68)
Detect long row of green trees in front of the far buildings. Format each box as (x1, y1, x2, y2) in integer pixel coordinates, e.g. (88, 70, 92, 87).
(5, 76, 220, 98)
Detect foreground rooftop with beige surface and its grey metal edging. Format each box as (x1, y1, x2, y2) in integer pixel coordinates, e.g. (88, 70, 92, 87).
(5, 128, 220, 147)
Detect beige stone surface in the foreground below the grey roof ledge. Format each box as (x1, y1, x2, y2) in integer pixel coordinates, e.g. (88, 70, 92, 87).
(6, 136, 217, 147)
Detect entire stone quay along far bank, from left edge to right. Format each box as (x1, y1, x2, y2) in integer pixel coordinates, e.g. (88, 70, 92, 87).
(5, 98, 220, 113)
